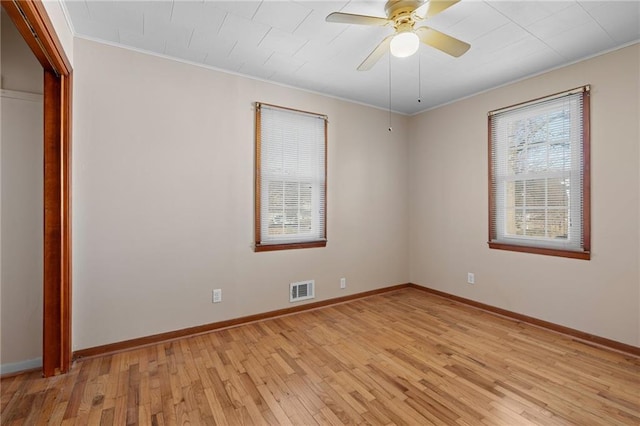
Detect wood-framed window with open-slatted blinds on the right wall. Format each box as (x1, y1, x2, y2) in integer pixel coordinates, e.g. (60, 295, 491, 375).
(489, 86, 590, 259)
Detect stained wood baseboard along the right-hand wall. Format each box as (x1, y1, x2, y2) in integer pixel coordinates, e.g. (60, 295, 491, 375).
(407, 283, 640, 356)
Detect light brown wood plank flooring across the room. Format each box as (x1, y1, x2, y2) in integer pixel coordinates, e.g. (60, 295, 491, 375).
(0, 289, 640, 426)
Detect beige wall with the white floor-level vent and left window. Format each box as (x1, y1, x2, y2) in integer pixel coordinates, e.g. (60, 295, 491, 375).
(73, 39, 409, 349)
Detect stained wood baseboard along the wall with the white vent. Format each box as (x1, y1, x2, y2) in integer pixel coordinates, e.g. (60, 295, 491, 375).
(73, 284, 412, 359)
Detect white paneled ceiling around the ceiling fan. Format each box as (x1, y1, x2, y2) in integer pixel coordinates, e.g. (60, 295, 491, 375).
(63, 0, 640, 114)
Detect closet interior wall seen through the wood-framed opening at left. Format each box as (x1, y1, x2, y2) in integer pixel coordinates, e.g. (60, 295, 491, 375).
(0, 11, 42, 374)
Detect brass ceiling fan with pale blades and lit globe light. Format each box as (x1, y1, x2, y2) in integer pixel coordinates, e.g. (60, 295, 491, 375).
(326, 0, 471, 71)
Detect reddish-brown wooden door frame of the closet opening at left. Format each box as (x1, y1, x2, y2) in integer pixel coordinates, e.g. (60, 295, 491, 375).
(2, 0, 73, 377)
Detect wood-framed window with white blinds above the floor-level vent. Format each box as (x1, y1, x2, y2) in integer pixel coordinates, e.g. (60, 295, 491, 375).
(255, 103, 327, 251)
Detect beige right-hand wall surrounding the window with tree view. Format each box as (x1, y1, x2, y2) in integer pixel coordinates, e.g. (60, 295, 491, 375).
(409, 44, 640, 346)
